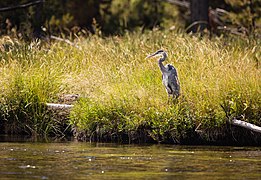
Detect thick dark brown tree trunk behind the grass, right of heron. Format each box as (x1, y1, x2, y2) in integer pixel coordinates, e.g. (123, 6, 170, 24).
(189, 0, 209, 33)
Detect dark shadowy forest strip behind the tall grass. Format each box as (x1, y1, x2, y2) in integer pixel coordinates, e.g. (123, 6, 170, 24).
(0, 0, 261, 38)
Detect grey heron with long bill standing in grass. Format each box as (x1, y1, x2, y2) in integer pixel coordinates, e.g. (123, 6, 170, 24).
(146, 50, 180, 99)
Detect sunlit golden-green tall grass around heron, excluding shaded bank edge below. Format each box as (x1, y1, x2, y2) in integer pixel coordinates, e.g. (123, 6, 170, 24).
(0, 31, 261, 139)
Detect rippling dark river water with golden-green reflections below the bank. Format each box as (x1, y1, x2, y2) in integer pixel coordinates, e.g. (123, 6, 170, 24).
(0, 139, 261, 179)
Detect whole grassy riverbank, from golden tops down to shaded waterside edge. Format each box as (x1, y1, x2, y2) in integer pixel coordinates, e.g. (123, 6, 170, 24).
(0, 31, 261, 143)
